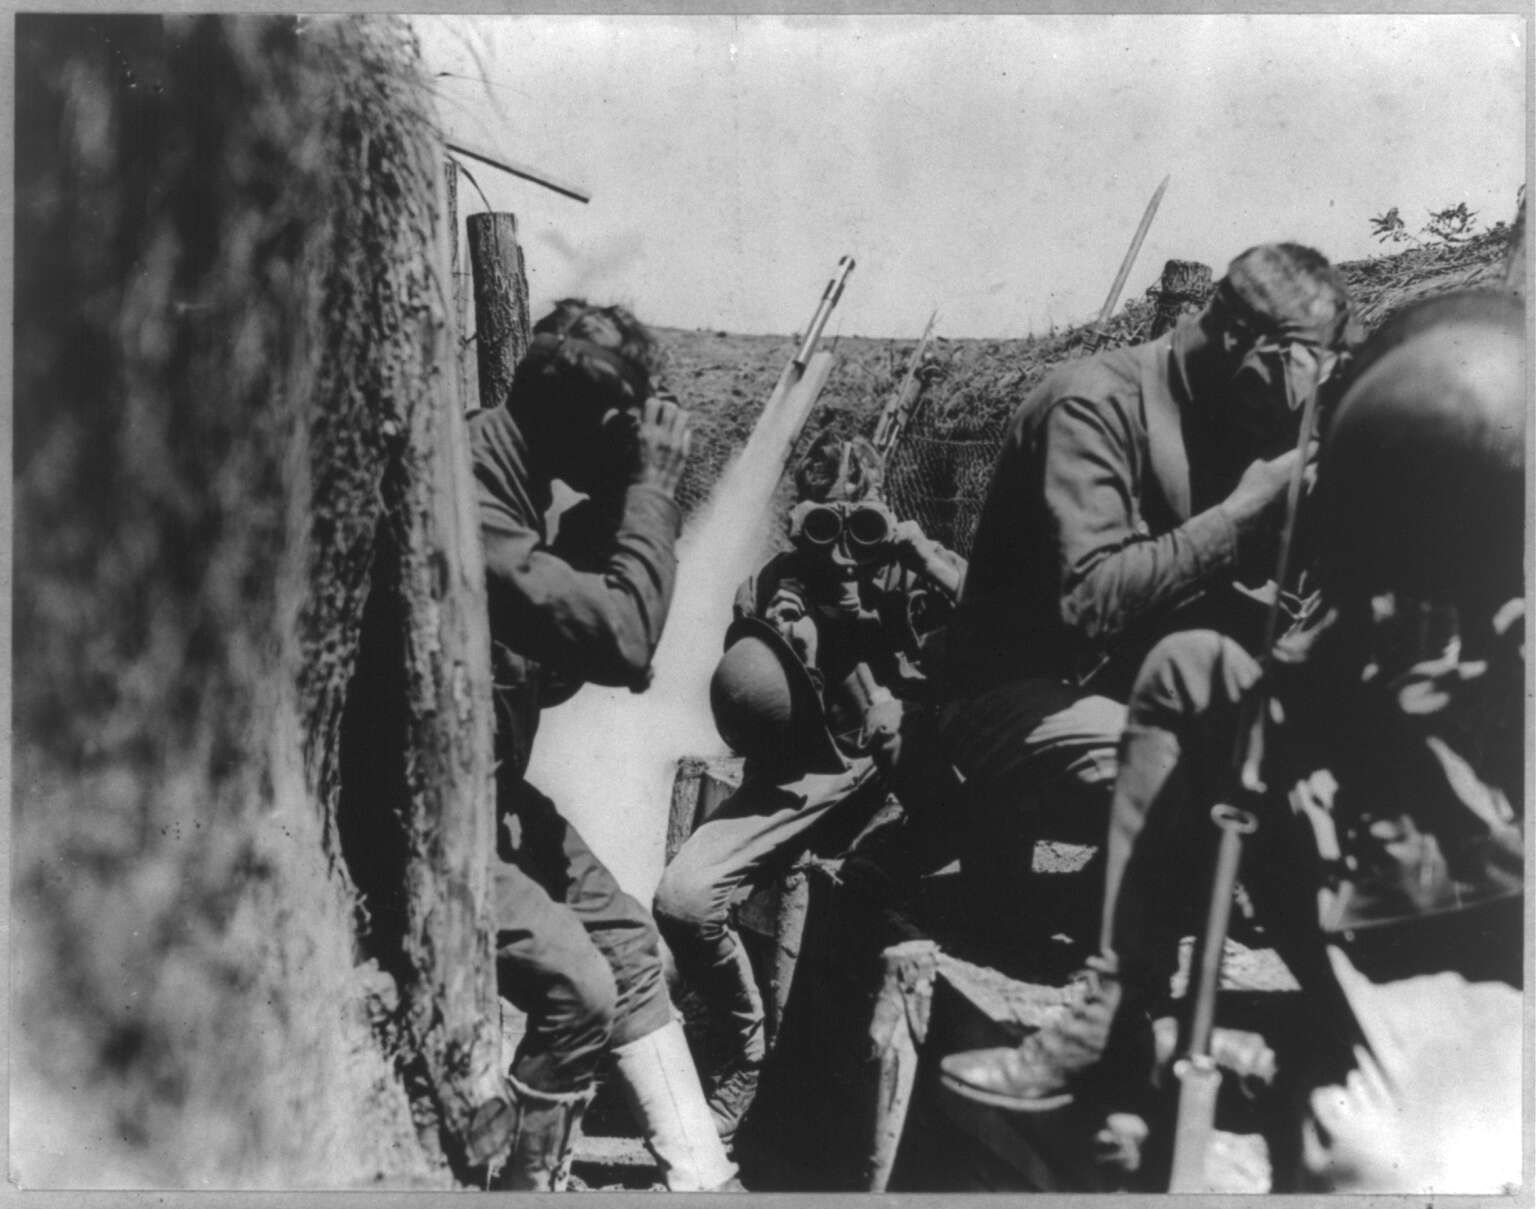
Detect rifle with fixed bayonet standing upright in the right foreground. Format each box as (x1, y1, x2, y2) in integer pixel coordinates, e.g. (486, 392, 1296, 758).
(1167, 359, 1319, 1192)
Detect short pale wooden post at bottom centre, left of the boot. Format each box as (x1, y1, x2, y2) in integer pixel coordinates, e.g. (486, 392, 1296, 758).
(868, 940, 938, 1192)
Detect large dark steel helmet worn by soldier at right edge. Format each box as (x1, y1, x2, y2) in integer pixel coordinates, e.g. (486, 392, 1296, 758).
(1316, 292, 1528, 621)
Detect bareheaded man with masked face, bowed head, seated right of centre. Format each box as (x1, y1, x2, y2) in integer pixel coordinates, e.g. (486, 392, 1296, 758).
(937, 244, 1349, 939)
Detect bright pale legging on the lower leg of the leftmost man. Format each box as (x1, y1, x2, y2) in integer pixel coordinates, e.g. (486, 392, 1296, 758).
(613, 1020, 736, 1192)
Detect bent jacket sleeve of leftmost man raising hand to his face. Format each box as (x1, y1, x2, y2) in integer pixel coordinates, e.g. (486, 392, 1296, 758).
(481, 485, 680, 688)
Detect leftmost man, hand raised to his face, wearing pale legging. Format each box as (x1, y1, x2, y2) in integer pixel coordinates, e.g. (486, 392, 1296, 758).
(470, 300, 740, 1191)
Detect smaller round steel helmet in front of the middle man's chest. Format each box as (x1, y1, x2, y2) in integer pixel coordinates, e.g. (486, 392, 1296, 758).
(710, 618, 848, 773)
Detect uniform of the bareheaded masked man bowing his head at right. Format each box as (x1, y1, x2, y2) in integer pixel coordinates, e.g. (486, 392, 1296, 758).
(938, 325, 1273, 915)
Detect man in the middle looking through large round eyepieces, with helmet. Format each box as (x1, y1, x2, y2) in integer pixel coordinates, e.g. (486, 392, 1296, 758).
(654, 433, 965, 1140)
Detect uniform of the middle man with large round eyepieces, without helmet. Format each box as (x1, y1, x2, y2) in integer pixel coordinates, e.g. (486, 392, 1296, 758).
(654, 516, 963, 1137)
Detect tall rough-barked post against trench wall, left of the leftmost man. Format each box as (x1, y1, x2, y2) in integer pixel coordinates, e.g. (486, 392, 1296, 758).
(390, 155, 511, 1163)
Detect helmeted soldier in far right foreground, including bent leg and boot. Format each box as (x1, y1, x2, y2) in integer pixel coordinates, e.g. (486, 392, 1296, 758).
(942, 292, 1528, 1194)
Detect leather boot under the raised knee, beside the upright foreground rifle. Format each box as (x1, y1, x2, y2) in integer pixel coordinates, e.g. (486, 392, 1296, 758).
(940, 957, 1152, 1112)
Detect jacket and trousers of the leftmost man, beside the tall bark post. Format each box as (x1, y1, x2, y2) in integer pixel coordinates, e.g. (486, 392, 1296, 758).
(470, 407, 680, 1091)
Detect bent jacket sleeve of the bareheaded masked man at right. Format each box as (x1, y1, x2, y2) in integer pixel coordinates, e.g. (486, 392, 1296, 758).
(1041, 398, 1236, 642)
